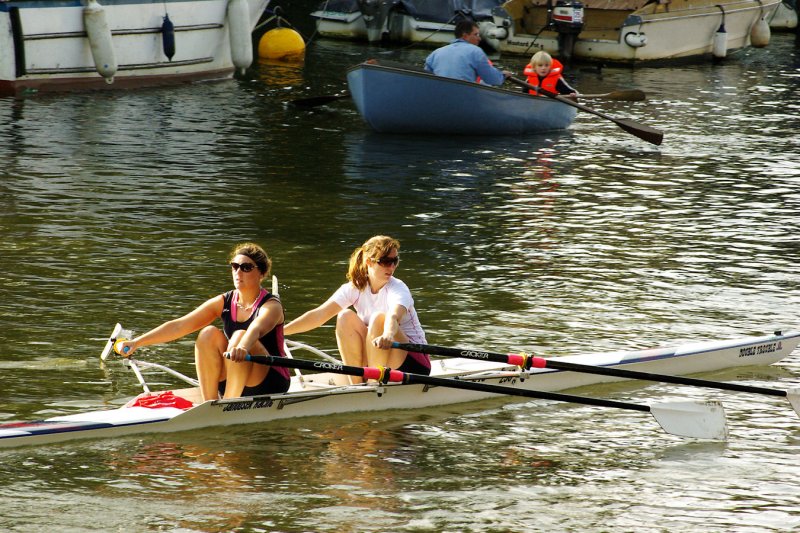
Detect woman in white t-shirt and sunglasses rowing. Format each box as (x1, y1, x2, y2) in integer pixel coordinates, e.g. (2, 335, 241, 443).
(283, 235, 431, 382)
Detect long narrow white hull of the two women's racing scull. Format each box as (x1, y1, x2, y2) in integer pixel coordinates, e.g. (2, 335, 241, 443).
(0, 331, 800, 448)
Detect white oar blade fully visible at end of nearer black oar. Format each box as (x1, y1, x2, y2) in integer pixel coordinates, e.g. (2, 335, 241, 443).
(650, 401, 728, 440)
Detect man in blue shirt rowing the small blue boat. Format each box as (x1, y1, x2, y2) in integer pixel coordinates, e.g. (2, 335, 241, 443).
(425, 20, 511, 85)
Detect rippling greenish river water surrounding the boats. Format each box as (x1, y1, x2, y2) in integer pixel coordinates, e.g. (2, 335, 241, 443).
(0, 7, 800, 532)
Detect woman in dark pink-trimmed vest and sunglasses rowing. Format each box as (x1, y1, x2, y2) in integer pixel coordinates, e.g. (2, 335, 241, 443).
(115, 243, 289, 401)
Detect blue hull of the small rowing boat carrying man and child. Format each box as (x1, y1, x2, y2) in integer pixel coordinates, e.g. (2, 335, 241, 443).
(347, 63, 576, 135)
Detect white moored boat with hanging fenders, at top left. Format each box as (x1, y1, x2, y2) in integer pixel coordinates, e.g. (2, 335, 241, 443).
(0, 0, 269, 96)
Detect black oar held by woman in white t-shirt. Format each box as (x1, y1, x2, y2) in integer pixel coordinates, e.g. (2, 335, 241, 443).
(392, 342, 800, 414)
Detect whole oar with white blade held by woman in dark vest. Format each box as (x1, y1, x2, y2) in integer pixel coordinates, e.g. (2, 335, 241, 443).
(233, 355, 728, 440)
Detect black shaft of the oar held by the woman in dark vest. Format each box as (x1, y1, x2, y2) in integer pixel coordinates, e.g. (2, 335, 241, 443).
(242, 355, 650, 413)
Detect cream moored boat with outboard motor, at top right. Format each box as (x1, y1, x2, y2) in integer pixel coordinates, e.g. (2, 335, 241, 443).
(481, 0, 781, 64)
